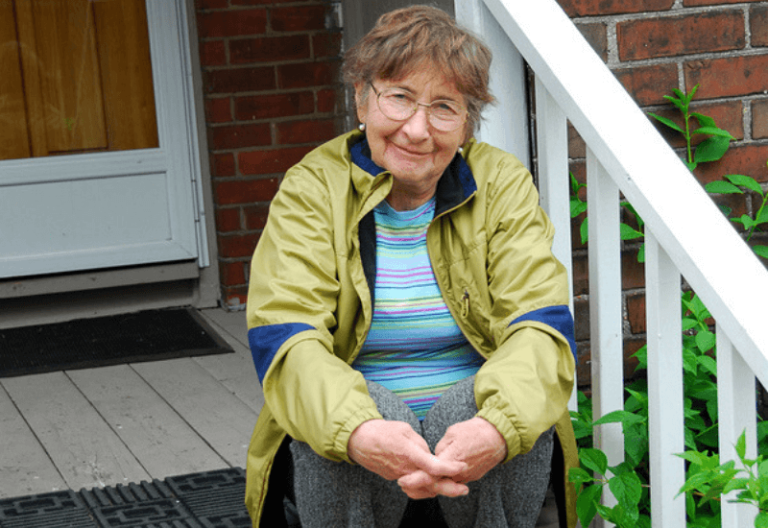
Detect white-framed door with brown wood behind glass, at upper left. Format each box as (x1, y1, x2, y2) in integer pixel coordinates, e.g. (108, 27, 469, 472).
(0, 0, 204, 278)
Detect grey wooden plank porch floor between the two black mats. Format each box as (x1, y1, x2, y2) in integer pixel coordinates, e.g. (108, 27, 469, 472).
(0, 309, 264, 498)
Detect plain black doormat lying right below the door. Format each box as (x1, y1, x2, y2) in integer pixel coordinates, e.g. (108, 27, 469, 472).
(0, 308, 232, 377)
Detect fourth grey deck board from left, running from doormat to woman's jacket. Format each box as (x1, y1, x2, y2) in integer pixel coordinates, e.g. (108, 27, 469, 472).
(133, 356, 258, 467)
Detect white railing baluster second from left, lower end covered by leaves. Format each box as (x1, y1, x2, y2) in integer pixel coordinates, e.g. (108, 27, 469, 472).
(587, 149, 624, 526)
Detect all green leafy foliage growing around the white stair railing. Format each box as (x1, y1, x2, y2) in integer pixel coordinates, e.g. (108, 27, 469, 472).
(569, 86, 768, 528)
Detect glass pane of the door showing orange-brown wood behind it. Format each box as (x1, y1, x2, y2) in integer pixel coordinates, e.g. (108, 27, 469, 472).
(0, 0, 158, 159)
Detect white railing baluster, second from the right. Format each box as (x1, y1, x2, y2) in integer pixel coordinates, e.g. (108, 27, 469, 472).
(645, 230, 685, 527)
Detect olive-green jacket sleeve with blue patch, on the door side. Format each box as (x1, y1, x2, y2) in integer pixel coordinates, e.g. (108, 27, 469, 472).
(247, 166, 381, 461)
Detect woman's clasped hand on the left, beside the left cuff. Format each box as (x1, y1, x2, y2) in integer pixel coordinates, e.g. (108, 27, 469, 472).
(347, 420, 467, 490)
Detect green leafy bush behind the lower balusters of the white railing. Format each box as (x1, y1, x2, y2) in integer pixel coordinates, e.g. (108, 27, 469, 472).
(569, 291, 720, 528)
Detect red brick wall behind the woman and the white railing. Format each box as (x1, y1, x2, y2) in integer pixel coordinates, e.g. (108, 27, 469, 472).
(196, 0, 768, 344)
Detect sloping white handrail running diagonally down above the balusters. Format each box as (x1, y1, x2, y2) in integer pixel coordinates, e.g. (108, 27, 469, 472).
(484, 0, 768, 385)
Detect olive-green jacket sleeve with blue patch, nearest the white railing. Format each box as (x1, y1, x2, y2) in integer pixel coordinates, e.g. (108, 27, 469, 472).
(475, 156, 575, 460)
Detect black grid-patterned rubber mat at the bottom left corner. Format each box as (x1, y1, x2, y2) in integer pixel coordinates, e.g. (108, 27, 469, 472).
(0, 468, 251, 528)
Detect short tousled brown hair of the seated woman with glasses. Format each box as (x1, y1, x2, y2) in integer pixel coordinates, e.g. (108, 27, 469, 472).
(343, 5, 494, 134)
